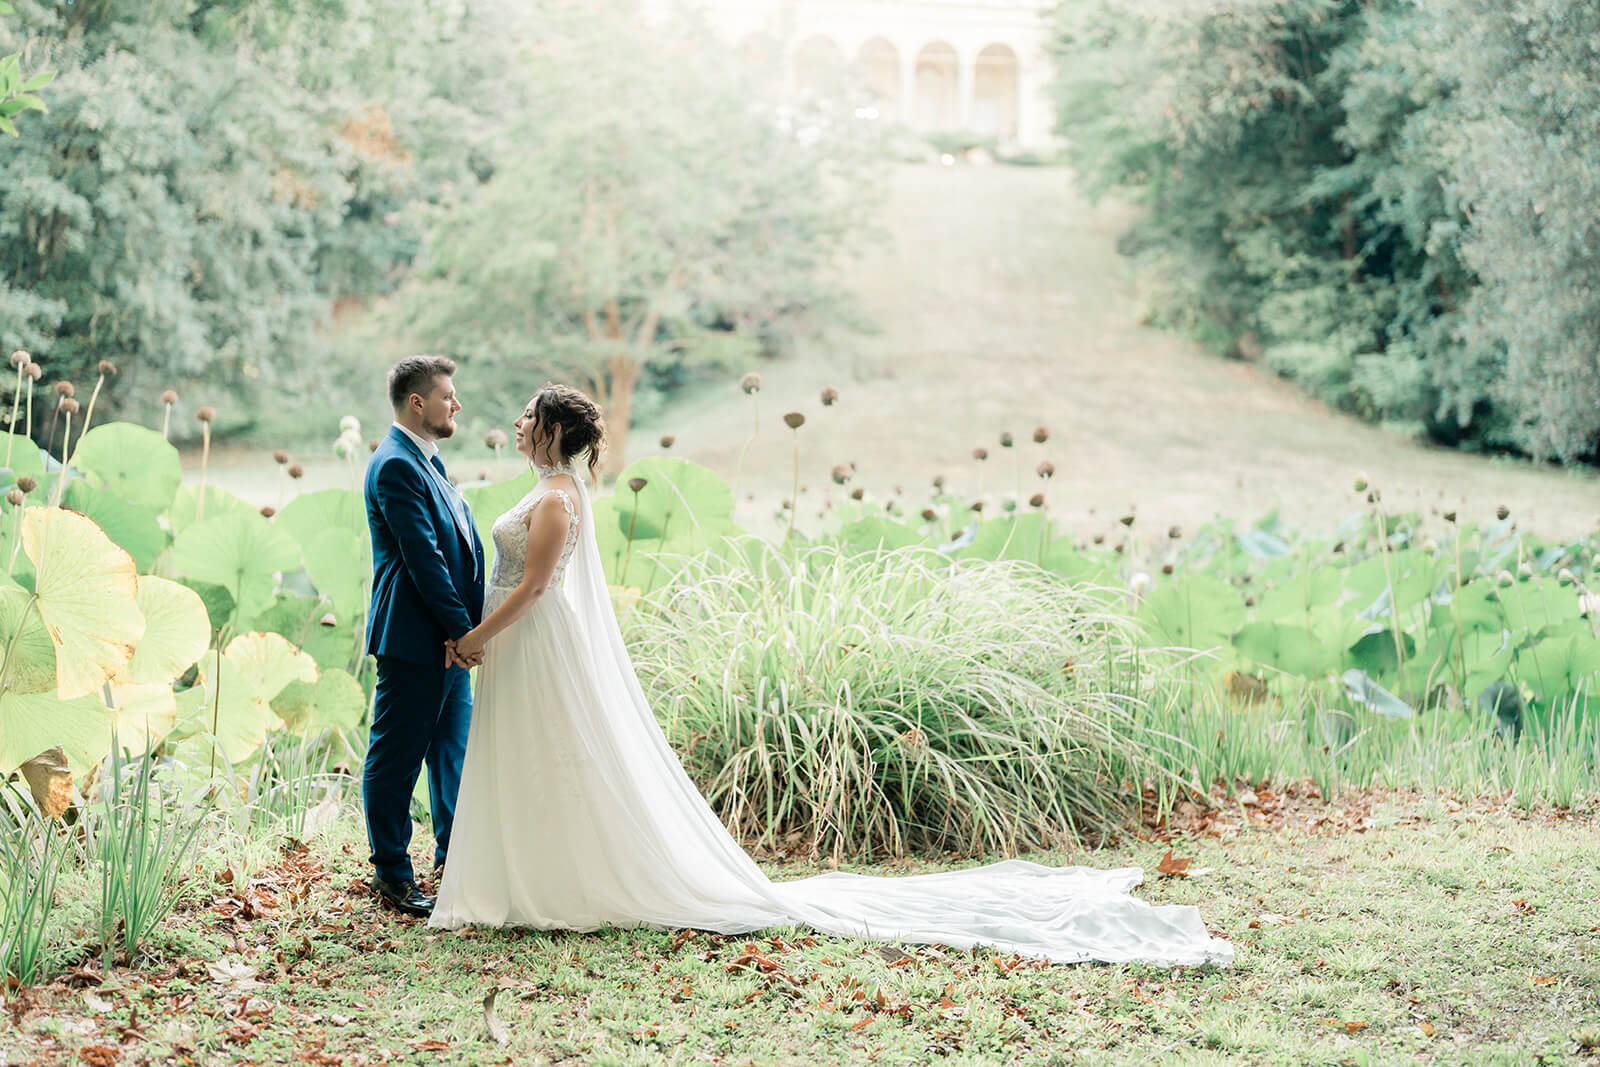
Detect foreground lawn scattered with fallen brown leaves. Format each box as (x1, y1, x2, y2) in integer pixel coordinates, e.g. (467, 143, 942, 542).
(0, 787, 1600, 1064)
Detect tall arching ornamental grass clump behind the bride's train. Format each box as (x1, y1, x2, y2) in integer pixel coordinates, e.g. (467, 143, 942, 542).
(627, 539, 1168, 856)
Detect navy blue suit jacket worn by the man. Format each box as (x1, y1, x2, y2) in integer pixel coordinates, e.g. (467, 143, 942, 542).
(365, 426, 483, 664)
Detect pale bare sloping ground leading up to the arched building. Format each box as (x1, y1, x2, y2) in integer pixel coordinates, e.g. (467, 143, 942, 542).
(200, 166, 1600, 537)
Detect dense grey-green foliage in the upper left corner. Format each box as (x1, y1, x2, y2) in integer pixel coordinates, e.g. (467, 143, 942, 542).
(0, 0, 504, 434)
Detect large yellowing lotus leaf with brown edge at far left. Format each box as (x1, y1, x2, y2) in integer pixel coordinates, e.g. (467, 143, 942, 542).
(22, 507, 144, 701)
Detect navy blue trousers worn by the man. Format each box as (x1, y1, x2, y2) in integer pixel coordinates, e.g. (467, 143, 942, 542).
(362, 649, 472, 881)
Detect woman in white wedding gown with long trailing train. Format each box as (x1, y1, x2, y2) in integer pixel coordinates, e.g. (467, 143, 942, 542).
(429, 386, 1234, 965)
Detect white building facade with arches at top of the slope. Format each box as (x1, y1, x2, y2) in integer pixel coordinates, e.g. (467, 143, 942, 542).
(645, 0, 1054, 149)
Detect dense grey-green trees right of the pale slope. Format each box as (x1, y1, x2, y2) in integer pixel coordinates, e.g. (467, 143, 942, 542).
(1056, 0, 1600, 461)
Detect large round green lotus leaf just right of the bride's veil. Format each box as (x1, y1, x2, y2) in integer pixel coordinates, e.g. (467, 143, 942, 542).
(611, 456, 733, 552)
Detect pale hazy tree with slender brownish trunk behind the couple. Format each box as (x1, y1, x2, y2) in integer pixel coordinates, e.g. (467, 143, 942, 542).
(395, 5, 880, 472)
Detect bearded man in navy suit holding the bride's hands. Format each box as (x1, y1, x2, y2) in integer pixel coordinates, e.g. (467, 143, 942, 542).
(362, 355, 483, 915)
